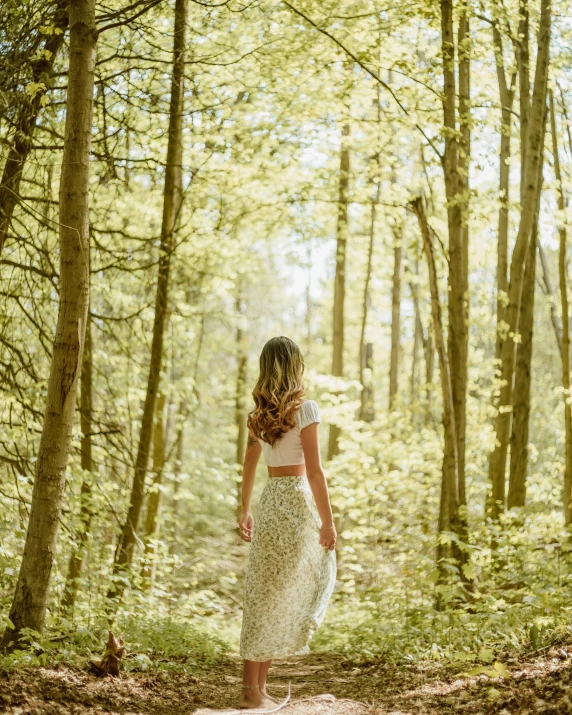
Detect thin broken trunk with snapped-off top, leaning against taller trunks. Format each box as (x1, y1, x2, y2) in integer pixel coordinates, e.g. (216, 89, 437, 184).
(411, 197, 460, 592)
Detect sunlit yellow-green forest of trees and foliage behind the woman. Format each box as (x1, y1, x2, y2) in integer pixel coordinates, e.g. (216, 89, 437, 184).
(0, 0, 572, 704)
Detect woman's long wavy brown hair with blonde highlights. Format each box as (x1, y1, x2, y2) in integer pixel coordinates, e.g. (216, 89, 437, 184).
(247, 336, 306, 445)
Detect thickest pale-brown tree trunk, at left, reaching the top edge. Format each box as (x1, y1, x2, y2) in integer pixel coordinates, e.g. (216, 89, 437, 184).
(0, 0, 97, 648)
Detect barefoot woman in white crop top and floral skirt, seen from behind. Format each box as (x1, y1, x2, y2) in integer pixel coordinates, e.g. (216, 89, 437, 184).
(239, 337, 336, 708)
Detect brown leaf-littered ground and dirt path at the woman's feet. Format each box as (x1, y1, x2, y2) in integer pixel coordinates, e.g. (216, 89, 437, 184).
(0, 643, 572, 715)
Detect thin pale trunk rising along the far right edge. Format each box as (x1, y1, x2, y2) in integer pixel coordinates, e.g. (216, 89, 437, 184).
(550, 90, 572, 526)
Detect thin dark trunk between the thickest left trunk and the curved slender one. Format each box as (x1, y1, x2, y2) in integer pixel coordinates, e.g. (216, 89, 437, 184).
(62, 313, 93, 615)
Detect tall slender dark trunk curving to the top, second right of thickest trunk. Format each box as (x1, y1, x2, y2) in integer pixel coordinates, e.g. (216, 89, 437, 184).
(108, 0, 187, 598)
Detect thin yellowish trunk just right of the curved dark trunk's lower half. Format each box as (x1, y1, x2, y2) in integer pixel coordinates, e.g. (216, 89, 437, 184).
(141, 392, 165, 588)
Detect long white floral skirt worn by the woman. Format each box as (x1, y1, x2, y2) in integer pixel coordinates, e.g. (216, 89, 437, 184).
(240, 476, 336, 662)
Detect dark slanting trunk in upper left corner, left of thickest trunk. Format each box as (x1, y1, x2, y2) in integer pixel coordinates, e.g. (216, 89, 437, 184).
(0, 0, 69, 254)
